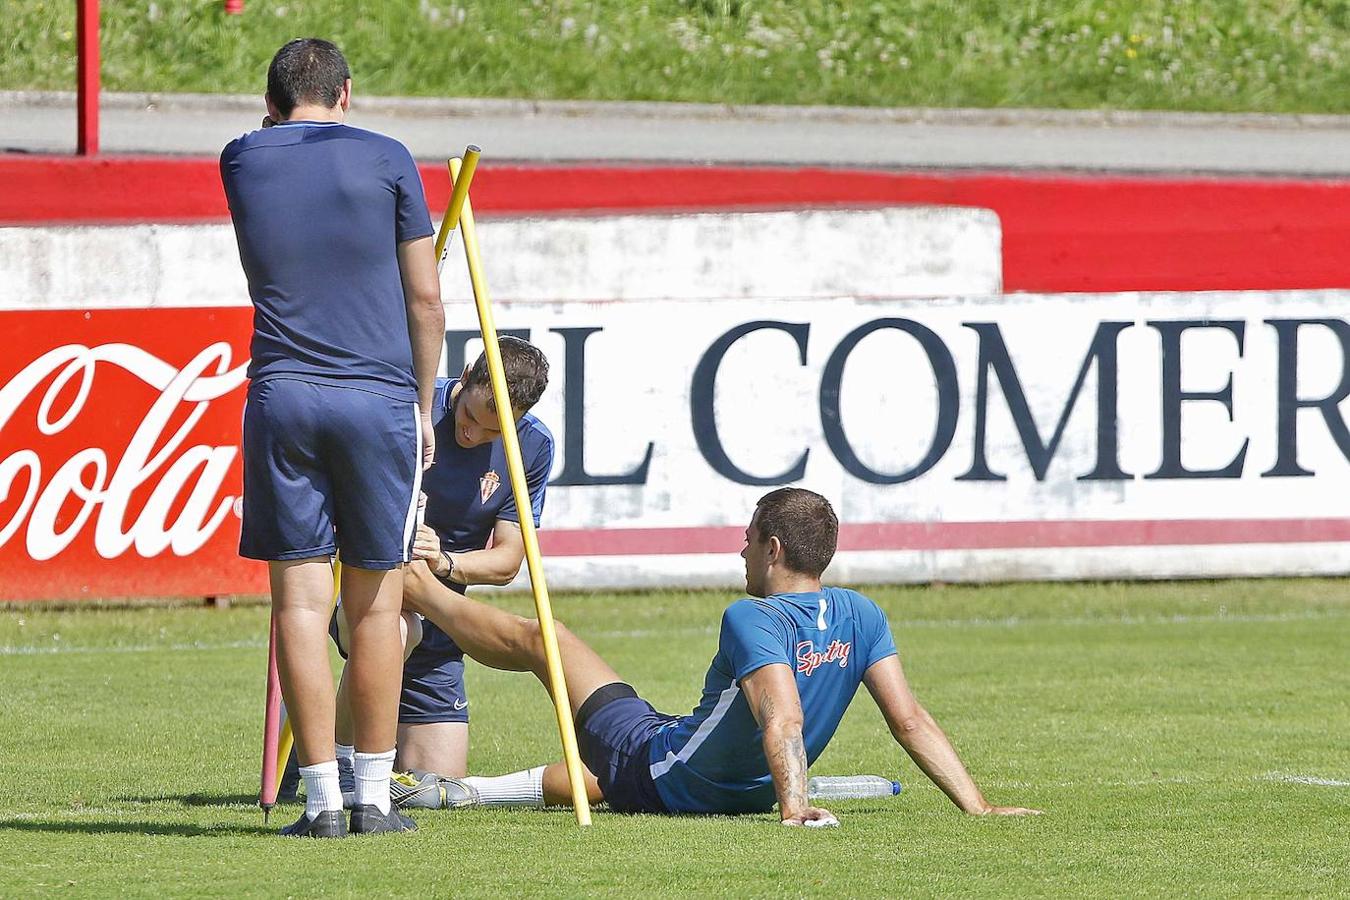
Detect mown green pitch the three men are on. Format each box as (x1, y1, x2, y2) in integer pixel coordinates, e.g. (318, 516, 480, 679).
(0, 580, 1350, 897)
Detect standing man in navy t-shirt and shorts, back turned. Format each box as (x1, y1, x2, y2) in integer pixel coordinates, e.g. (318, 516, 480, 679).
(220, 38, 444, 837)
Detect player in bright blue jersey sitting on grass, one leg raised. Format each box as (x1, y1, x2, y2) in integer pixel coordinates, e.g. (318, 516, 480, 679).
(404, 487, 1035, 824)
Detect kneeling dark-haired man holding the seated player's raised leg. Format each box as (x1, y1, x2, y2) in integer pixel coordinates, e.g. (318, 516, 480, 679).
(279, 336, 554, 806)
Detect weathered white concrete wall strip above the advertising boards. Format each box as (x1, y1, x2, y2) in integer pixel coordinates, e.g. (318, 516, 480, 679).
(0, 206, 1002, 309)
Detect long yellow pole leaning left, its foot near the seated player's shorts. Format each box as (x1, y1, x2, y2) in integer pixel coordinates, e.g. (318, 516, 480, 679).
(450, 159, 590, 826)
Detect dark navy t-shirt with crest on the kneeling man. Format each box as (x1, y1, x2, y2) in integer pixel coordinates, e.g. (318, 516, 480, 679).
(423, 378, 554, 553)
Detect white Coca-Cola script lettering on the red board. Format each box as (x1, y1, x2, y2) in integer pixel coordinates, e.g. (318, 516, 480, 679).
(0, 341, 247, 560)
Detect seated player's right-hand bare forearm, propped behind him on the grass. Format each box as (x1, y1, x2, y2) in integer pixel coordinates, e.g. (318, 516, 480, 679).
(863, 656, 1040, 815)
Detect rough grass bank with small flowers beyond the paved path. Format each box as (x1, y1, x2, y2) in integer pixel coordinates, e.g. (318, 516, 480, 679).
(0, 0, 1350, 113)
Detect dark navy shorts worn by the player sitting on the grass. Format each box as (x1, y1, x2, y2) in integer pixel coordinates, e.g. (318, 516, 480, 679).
(576, 681, 679, 812)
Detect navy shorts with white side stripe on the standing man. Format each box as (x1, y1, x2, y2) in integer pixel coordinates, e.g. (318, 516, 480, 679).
(239, 378, 421, 569)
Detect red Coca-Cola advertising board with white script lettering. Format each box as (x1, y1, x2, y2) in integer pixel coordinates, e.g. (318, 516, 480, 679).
(0, 308, 267, 600)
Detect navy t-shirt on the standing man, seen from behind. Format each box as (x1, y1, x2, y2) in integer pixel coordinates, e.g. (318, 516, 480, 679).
(220, 121, 433, 401)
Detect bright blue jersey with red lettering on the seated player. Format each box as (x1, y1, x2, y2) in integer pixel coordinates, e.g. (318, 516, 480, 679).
(648, 587, 895, 812)
